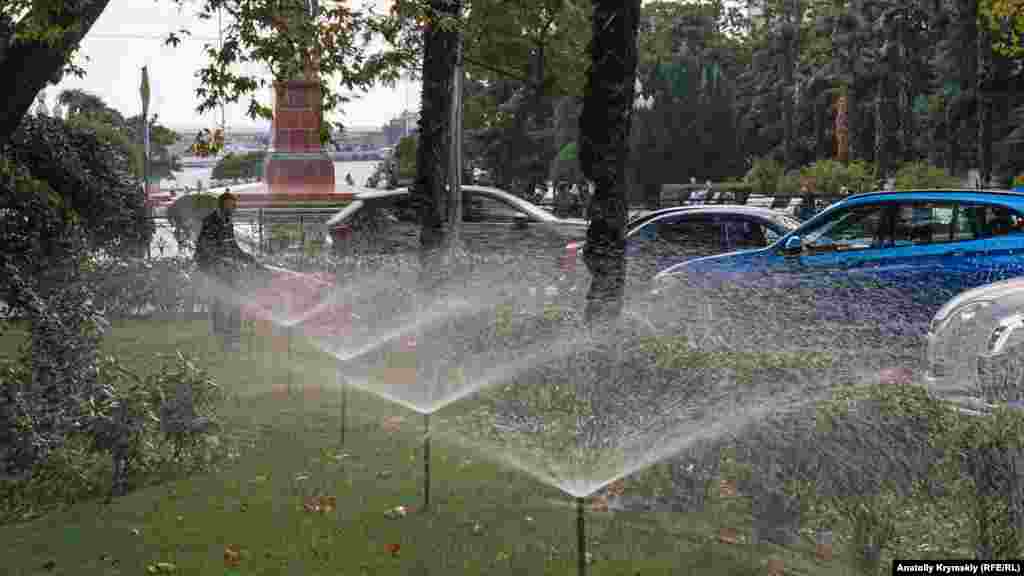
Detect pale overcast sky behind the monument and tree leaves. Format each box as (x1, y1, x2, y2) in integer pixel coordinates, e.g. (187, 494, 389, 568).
(39, 0, 420, 130)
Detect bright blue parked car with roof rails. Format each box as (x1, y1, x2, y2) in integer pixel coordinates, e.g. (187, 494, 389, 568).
(655, 190, 1024, 324)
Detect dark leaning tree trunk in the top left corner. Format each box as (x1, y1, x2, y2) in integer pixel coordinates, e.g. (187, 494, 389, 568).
(0, 0, 111, 146)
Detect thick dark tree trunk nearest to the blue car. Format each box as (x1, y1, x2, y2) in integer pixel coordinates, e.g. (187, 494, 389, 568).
(579, 0, 640, 322)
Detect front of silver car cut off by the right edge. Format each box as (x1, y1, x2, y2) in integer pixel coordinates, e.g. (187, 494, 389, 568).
(925, 278, 1024, 410)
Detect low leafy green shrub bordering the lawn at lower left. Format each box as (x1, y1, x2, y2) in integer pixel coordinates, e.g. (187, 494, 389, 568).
(0, 344, 231, 523)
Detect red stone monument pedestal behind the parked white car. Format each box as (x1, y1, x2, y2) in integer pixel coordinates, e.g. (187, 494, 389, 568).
(263, 80, 351, 199)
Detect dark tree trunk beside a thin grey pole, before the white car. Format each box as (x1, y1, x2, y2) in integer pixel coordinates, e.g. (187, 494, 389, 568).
(413, 0, 462, 289)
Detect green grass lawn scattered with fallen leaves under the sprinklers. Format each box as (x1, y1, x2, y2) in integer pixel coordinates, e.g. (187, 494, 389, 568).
(0, 321, 853, 576)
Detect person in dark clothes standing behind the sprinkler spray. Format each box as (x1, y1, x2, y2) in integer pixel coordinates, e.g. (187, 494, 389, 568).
(196, 191, 256, 352)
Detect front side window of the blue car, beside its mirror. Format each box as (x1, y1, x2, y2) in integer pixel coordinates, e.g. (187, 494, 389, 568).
(803, 204, 889, 252)
